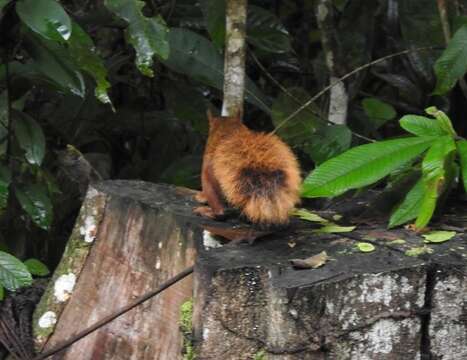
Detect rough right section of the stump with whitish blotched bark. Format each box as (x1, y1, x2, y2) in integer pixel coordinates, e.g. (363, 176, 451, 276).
(193, 212, 467, 360)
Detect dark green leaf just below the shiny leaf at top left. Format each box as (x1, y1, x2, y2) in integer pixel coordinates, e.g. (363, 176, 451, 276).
(25, 33, 85, 97)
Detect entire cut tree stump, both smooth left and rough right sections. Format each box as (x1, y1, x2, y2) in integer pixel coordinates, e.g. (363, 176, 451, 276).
(35, 181, 467, 360)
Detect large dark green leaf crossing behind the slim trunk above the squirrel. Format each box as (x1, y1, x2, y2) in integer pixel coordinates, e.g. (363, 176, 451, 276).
(163, 28, 270, 113)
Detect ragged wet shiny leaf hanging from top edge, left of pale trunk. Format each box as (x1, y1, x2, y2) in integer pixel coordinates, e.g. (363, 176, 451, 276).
(104, 0, 170, 77)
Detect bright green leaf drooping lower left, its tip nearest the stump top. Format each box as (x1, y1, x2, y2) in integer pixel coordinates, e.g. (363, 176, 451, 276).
(388, 179, 425, 228)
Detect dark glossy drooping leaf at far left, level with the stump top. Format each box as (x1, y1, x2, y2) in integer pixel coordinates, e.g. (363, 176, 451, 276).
(15, 184, 53, 230)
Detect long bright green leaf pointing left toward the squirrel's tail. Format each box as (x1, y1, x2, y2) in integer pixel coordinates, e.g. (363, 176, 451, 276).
(302, 137, 435, 197)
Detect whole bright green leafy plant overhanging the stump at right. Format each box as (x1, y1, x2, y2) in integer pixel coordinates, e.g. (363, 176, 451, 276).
(302, 107, 467, 230)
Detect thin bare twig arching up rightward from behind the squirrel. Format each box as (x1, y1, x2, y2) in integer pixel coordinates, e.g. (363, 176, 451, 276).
(272, 46, 436, 137)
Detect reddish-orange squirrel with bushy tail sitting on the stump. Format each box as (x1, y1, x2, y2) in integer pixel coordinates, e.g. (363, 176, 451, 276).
(195, 110, 301, 226)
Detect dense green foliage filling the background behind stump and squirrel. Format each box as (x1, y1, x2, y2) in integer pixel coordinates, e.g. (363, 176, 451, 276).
(0, 0, 467, 290)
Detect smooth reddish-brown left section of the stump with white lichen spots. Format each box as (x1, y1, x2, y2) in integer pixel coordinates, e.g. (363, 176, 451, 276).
(34, 181, 199, 360)
